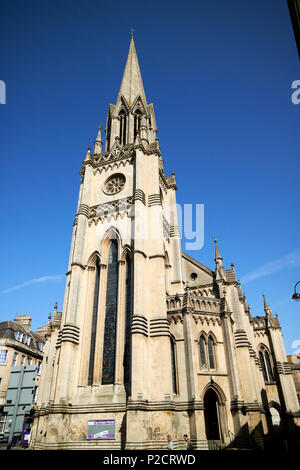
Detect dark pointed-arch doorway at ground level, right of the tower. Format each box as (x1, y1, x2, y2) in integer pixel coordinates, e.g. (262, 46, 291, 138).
(203, 388, 222, 441)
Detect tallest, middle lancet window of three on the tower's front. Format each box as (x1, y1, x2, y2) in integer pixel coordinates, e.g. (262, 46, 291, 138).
(102, 240, 118, 384)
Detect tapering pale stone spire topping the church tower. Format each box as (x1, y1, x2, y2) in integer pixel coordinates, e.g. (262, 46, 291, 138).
(117, 36, 147, 106)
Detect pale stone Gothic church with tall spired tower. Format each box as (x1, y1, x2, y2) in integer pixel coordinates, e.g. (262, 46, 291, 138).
(31, 38, 300, 450)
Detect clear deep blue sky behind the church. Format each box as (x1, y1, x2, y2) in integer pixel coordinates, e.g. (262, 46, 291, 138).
(0, 0, 300, 353)
